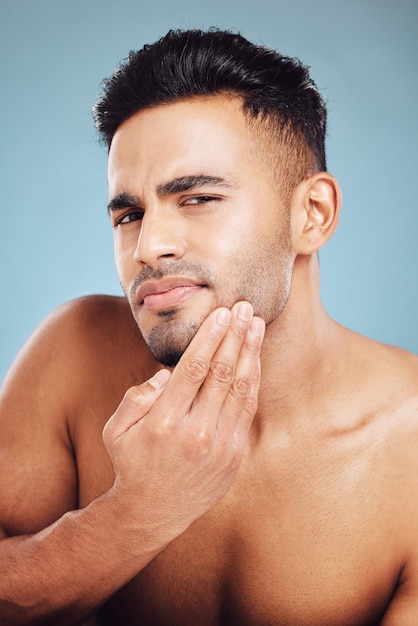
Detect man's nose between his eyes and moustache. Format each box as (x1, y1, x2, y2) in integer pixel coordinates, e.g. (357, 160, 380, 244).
(134, 209, 185, 267)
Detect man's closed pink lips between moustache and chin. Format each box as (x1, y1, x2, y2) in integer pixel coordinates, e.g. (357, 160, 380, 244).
(137, 277, 205, 310)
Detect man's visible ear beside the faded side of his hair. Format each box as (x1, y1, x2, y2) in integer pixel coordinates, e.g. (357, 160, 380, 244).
(291, 172, 341, 255)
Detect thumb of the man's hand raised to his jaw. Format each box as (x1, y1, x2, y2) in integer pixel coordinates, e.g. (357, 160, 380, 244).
(103, 369, 171, 445)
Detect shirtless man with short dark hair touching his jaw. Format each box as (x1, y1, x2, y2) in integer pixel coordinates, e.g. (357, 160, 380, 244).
(0, 26, 418, 626)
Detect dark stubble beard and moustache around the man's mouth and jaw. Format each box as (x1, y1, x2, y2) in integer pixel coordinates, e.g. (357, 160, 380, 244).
(125, 223, 294, 367)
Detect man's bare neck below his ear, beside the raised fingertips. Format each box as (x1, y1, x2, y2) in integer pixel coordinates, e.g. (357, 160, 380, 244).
(256, 256, 341, 430)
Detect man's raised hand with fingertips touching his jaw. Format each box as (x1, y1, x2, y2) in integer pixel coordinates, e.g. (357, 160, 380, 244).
(103, 302, 264, 544)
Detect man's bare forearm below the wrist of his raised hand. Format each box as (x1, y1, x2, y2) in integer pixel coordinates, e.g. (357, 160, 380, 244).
(0, 494, 164, 626)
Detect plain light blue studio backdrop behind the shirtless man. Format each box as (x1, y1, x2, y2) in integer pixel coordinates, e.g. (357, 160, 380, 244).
(0, 0, 418, 380)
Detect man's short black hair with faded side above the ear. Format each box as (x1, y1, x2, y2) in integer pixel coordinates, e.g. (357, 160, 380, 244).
(93, 28, 326, 177)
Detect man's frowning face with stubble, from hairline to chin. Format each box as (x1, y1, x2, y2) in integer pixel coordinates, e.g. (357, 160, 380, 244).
(109, 96, 294, 365)
